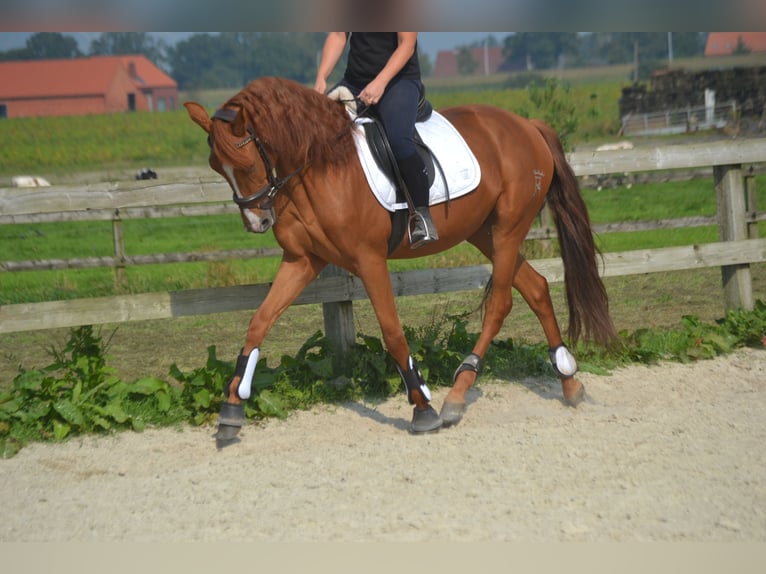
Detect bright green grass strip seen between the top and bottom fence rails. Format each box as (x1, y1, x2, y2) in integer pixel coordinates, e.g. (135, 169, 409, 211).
(0, 176, 766, 304)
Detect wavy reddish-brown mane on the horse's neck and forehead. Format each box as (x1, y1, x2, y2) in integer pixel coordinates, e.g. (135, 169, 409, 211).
(211, 77, 356, 173)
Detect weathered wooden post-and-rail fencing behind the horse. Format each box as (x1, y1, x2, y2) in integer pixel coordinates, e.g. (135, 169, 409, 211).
(0, 139, 766, 354)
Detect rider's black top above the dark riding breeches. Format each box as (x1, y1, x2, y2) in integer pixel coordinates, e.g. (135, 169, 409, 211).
(344, 32, 420, 87)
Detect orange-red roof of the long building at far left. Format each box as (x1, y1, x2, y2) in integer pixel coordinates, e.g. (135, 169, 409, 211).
(0, 55, 176, 99)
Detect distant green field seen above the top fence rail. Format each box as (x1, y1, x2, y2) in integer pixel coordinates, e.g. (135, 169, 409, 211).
(0, 54, 762, 181)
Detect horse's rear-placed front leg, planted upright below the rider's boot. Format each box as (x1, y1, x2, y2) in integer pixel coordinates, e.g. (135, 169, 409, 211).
(358, 259, 442, 434)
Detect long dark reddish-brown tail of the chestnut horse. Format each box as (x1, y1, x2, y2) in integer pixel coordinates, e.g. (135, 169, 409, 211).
(532, 120, 617, 346)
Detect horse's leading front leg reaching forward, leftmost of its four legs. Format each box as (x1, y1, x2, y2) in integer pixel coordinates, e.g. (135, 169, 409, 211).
(216, 256, 326, 447)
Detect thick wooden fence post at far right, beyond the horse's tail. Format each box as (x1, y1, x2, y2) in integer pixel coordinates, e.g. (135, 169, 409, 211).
(713, 165, 754, 310)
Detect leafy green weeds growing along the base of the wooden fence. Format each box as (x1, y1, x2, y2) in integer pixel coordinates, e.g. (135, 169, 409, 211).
(0, 300, 766, 458)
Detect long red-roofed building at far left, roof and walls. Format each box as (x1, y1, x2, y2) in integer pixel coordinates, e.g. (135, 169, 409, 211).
(0, 55, 178, 118)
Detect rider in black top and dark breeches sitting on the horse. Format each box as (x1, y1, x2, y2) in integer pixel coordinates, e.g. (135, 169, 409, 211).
(314, 32, 439, 249)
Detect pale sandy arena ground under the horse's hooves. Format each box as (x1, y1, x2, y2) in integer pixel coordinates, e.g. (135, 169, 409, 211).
(0, 349, 766, 544)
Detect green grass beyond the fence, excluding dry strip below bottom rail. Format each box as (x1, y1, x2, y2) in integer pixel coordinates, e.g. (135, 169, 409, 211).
(0, 68, 764, 304)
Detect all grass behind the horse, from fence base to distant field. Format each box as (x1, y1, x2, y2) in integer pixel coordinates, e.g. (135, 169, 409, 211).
(0, 56, 766, 382)
